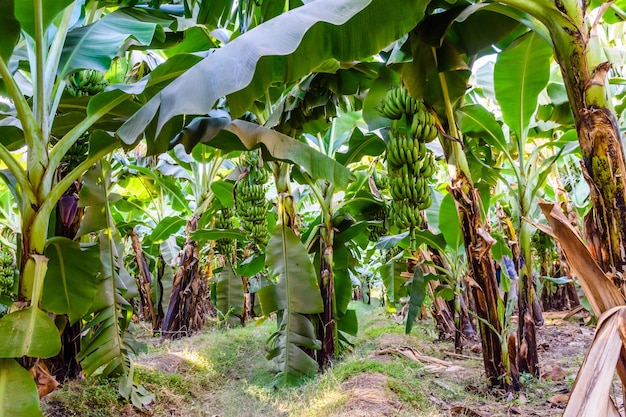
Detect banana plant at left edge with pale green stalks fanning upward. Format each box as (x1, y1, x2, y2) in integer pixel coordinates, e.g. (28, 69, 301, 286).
(0, 1, 185, 410)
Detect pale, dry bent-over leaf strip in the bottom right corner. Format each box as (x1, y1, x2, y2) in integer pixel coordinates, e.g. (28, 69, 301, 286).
(563, 306, 626, 417)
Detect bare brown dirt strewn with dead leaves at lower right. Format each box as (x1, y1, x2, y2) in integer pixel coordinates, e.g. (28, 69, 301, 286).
(340, 312, 596, 417)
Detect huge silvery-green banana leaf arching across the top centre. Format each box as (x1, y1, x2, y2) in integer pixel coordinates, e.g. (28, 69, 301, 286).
(117, 0, 428, 144)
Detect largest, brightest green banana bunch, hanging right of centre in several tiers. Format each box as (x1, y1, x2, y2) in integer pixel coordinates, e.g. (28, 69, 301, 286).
(378, 85, 437, 229)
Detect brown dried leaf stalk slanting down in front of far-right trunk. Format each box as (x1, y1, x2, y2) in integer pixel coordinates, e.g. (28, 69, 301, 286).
(539, 200, 625, 317)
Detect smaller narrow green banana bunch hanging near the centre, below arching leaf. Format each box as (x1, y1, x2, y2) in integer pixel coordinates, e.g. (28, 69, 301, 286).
(235, 149, 269, 247)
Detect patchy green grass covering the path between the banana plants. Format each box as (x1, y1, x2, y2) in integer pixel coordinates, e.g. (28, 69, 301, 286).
(39, 303, 584, 417)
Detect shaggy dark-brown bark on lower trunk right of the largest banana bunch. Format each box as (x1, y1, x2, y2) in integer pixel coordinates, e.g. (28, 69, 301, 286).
(449, 173, 518, 391)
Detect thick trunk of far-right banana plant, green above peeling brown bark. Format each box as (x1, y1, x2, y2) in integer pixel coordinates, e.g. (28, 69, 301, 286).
(555, 1, 626, 293)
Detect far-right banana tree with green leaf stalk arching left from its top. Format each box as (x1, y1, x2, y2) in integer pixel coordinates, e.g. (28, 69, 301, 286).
(490, 0, 626, 292)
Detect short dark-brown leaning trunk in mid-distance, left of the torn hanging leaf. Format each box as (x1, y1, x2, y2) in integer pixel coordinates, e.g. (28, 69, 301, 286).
(161, 215, 207, 338)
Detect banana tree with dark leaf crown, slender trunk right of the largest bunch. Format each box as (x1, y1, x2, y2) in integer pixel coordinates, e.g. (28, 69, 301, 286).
(376, 3, 519, 390)
